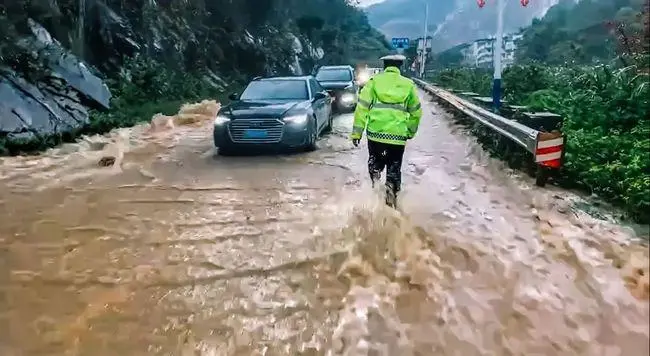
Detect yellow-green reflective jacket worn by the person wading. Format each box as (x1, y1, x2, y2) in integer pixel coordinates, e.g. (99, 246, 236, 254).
(351, 67, 422, 145)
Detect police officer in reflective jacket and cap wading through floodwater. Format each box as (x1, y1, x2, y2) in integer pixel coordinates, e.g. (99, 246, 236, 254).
(350, 54, 422, 208)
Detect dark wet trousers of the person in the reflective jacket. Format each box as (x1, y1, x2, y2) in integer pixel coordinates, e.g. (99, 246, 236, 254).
(368, 140, 404, 207)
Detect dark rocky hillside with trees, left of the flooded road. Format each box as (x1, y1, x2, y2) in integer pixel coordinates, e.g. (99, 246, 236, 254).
(0, 0, 388, 147)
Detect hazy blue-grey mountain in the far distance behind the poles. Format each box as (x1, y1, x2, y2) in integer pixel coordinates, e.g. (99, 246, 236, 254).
(366, 0, 557, 52)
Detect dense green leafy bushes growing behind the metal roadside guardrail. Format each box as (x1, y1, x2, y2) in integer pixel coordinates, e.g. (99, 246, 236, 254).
(422, 64, 650, 222)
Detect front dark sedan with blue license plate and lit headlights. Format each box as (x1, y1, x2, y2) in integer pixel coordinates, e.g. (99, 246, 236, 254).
(214, 76, 332, 153)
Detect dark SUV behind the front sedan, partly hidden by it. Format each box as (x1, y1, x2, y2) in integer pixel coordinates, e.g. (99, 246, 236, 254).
(316, 66, 359, 111)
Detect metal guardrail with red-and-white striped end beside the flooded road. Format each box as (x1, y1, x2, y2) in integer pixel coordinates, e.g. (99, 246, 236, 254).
(413, 78, 564, 186)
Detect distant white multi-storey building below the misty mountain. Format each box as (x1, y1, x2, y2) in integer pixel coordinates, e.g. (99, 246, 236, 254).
(463, 34, 522, 68)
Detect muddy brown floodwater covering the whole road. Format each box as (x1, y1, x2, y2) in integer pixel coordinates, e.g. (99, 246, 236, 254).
(0, 93, 649, 356)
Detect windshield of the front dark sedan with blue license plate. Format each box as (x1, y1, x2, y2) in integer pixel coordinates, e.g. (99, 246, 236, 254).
(240, 80, 309, 100)
